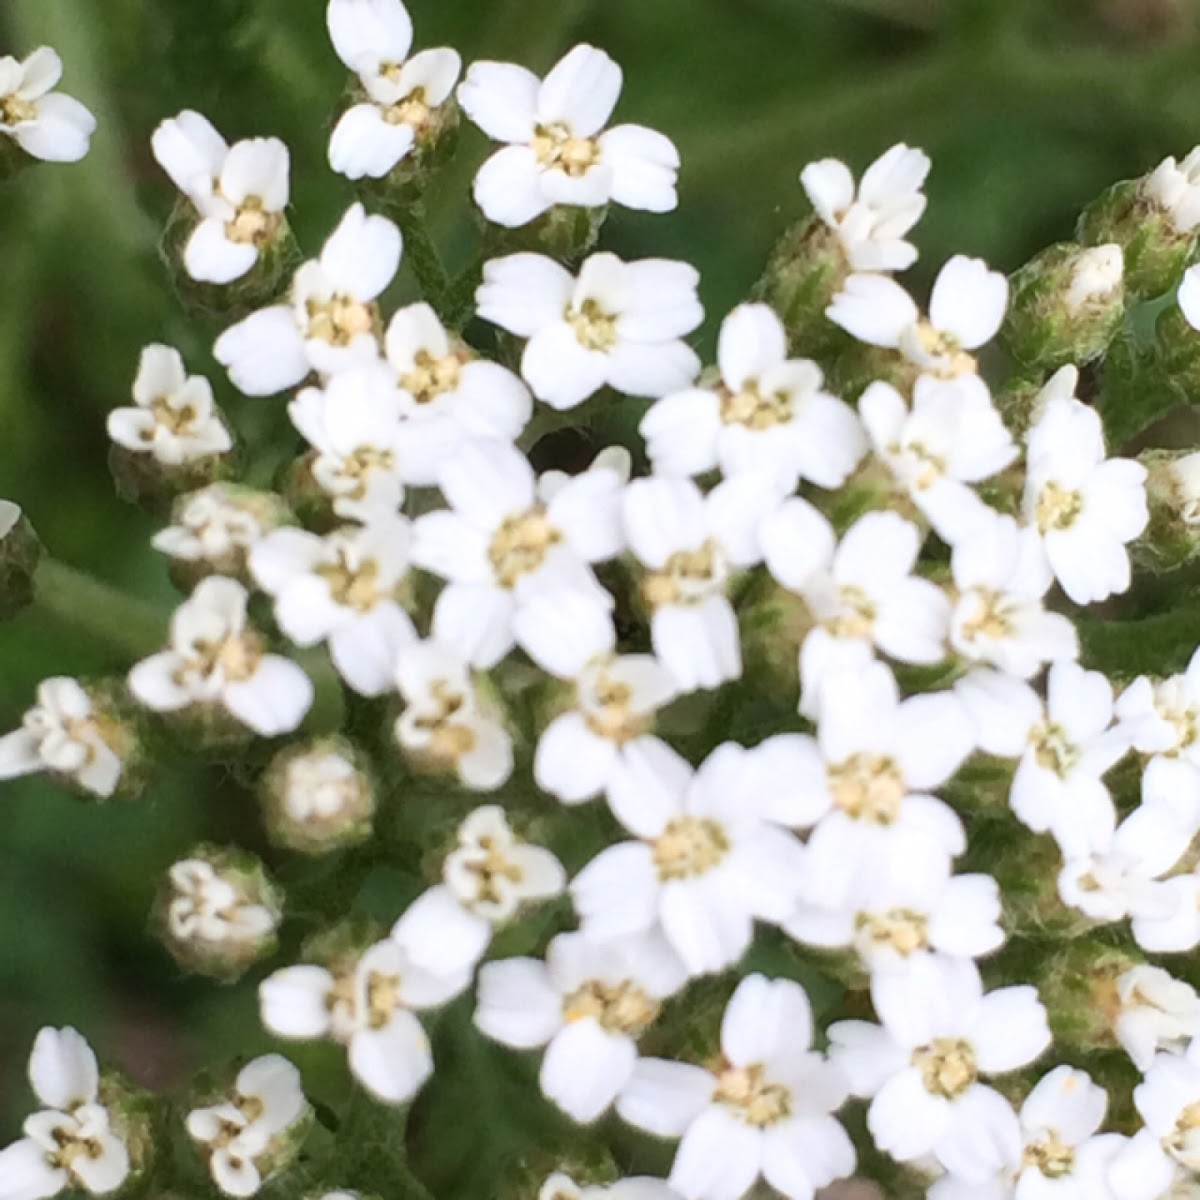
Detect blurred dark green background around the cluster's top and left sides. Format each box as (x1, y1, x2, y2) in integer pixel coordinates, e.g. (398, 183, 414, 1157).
(0, 0, 1200, 1144)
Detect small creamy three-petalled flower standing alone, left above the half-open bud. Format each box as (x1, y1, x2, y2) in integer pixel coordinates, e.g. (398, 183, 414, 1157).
(108, 344, 233, 467)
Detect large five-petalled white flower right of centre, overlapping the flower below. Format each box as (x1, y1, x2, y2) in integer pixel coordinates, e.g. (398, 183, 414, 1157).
(756, 662, 974, 908)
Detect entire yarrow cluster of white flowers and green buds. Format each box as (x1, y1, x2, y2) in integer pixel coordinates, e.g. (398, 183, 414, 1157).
(11, 0, 1200, 1200)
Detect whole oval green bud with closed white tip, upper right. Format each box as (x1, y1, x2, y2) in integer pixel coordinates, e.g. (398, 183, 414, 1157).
(1002, 242, 1124, 371)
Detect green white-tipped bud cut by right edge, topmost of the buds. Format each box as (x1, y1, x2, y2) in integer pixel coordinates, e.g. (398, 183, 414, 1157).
(1078, 165, 1200, 298)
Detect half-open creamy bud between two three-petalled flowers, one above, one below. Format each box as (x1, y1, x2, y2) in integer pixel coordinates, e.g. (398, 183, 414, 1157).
(151, 484, 293, 593)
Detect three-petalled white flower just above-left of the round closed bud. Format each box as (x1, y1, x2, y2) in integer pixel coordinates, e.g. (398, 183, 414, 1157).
(130, 576, 312, 737)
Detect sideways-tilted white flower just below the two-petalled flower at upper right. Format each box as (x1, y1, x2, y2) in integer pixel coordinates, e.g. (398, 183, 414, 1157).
(858, 376, 1018, 545)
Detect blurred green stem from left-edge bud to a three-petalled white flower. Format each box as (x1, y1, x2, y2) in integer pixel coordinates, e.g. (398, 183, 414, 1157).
(34, 558, 167, 658)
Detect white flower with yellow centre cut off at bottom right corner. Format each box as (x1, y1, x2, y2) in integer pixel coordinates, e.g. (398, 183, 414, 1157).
(1109, 1043, 1200, 1200)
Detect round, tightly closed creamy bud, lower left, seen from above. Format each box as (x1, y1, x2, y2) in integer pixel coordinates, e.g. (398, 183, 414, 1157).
(263, 738, 376, 854)
